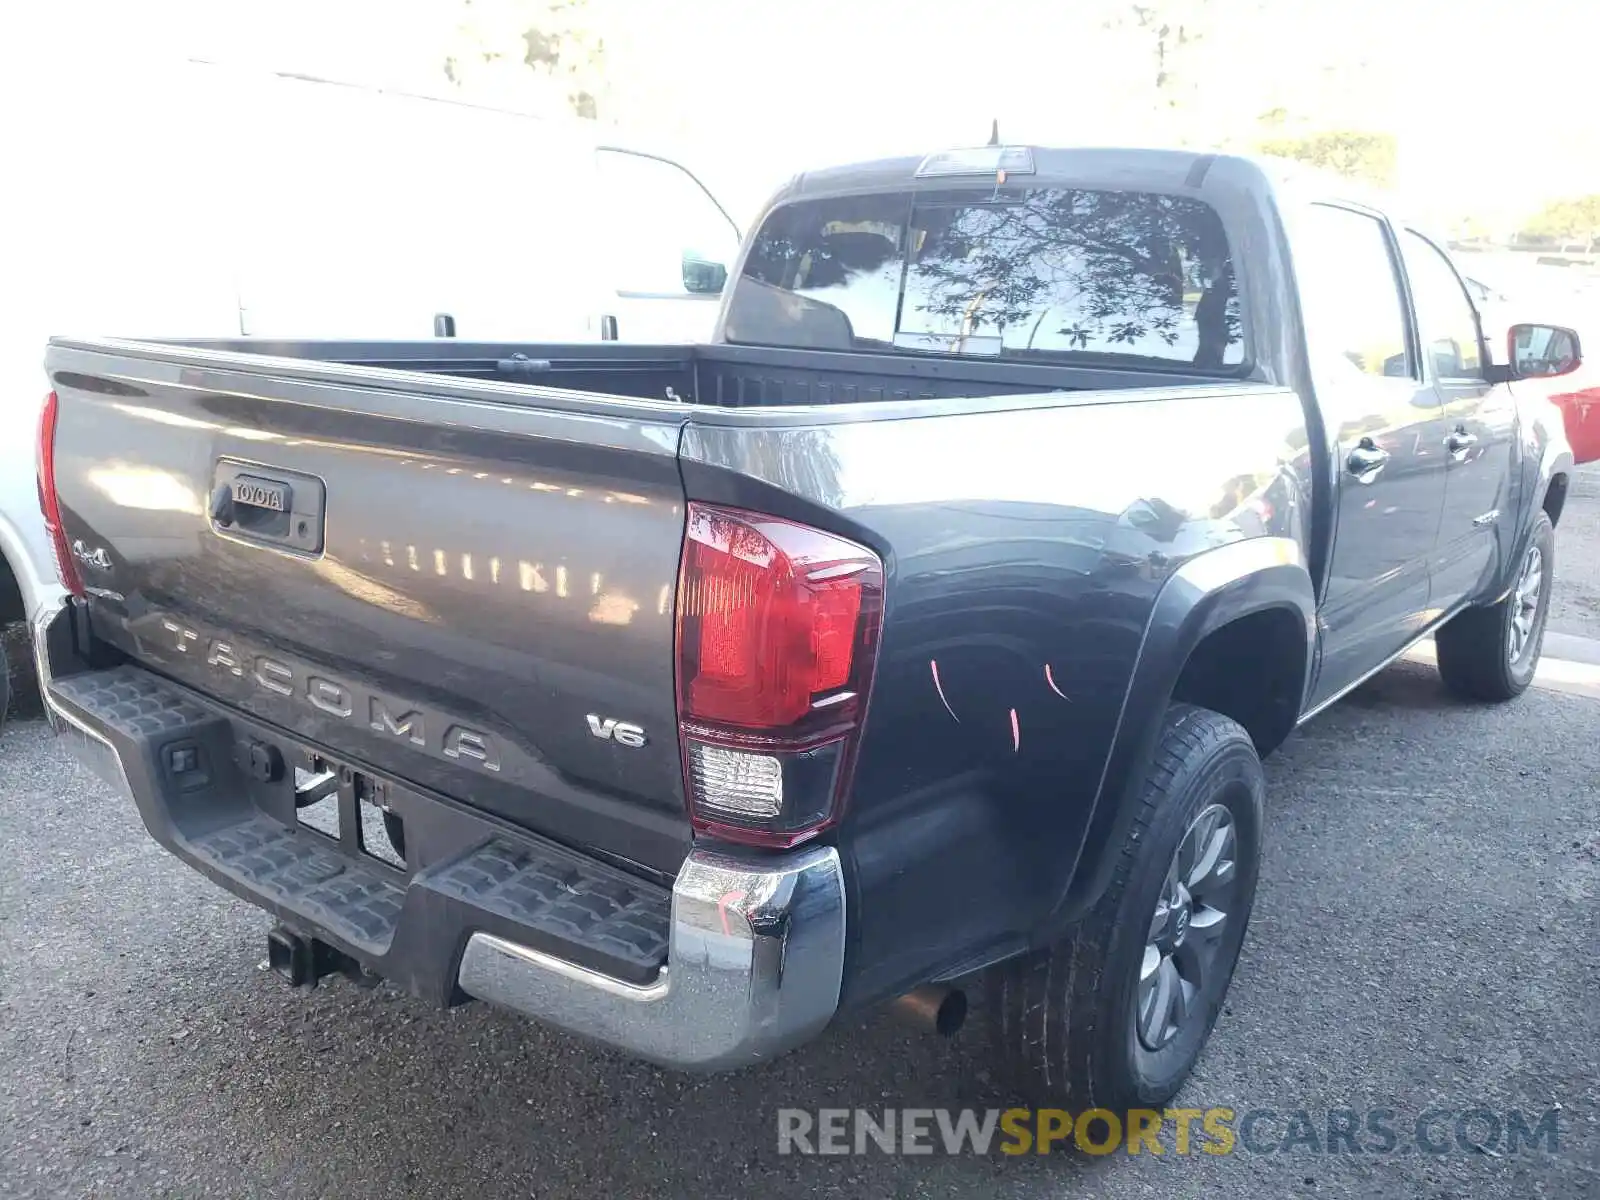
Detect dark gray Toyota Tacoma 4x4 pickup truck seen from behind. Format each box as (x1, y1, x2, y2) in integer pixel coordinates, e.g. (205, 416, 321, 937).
(35, 147, 1579, 1109)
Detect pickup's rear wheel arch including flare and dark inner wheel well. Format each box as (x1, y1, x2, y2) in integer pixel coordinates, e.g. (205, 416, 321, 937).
(1048, 538, 1317, 931)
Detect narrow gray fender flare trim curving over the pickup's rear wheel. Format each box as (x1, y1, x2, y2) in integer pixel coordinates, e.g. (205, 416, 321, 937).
(1048, 538, 1317, 934)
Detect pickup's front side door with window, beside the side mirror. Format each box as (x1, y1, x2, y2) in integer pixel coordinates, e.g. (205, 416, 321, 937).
(1400, 229, 1517, 608)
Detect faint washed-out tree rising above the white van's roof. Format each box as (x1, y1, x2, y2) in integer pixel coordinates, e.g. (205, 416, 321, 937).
(443, 0, 606, 118)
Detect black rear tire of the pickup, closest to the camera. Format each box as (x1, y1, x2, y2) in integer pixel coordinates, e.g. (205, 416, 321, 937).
(987, 704, 1266, 1114)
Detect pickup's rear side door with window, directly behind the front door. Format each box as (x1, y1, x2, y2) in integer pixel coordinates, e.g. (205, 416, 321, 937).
(1293, 205, 1446, 704)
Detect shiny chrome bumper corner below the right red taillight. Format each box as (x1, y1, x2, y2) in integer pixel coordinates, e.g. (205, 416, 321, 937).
(459, 846, 845, 1070)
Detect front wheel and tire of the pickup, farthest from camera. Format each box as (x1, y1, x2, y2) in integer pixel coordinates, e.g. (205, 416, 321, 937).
(1434, 512, 1555, 702)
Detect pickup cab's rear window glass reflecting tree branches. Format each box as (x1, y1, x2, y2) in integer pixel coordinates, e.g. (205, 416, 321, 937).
(726, 187, 1245, 370)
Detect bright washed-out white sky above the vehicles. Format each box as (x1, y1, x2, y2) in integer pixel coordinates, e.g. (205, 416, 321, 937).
(12, 0, 1600, 221)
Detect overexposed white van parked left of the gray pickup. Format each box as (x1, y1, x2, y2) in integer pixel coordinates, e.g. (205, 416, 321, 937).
(0, 61, 739, 714)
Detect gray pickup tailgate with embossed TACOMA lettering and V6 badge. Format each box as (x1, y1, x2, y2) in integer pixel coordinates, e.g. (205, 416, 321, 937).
(48, 344, 690, 872)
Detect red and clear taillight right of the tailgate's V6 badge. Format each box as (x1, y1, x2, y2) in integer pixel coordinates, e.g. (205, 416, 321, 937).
(677, 504, 883, 846)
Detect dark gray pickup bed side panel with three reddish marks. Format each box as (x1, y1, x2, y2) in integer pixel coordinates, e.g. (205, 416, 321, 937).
(680, 384, 1310, 1003)
